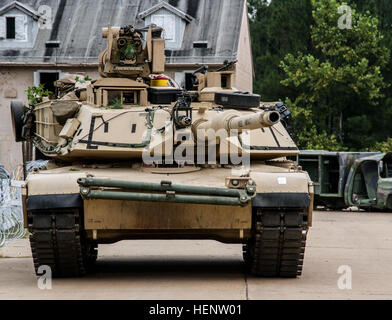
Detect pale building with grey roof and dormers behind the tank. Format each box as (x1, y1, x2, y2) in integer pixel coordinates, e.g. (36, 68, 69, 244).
(0, 0, 253, 169)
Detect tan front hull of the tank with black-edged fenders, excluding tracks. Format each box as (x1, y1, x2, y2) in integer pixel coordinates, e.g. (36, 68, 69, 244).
(25, 163, 311, 243)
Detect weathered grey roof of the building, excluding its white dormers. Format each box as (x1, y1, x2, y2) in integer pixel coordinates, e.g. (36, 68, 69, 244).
(0, 0, 245, 65)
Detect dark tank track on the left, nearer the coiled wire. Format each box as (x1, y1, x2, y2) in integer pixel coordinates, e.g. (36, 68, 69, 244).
(28, 209, 98, 278)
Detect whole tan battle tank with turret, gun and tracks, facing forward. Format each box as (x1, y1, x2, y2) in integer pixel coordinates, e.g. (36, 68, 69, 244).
(12, 26, 313, 277)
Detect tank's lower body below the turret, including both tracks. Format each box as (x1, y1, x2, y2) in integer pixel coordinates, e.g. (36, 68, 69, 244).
(24, 162, 313, 277)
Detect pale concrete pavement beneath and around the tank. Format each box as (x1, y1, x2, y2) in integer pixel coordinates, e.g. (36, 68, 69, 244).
(0, 211, 392, 300)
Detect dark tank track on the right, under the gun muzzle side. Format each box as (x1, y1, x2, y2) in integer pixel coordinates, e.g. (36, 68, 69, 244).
(243, 208, 308, 278)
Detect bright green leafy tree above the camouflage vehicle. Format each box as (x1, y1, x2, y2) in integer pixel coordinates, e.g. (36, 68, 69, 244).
(281, 0, 390, 149)
